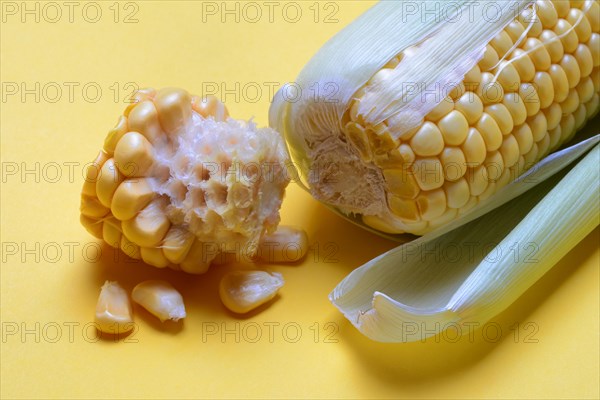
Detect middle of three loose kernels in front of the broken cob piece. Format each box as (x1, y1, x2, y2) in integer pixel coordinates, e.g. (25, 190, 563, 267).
(131, 280, 186, 322)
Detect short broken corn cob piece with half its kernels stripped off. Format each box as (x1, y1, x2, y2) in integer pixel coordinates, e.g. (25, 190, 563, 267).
(80, 88, 289, 273)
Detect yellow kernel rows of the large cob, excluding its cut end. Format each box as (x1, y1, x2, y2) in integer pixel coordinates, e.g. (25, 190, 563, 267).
(328, 0, 600, 235)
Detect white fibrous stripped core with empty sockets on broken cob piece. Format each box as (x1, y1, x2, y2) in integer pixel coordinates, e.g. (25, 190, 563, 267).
(153, 113, 287, 250)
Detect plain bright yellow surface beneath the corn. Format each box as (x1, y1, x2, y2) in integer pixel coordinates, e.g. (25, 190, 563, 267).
(0, 1, 600, 398)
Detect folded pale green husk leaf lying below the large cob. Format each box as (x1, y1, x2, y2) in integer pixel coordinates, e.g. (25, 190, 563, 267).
(330, 141, 600, 342)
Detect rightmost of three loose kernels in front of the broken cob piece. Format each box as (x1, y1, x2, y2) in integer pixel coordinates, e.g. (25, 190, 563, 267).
(219, 271, 284, 314)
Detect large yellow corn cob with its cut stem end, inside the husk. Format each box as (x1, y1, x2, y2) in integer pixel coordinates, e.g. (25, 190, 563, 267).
(271, 0, 600, 235)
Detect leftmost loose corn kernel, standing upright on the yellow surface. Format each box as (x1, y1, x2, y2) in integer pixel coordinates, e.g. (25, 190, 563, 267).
(95, 281, 133, 334)
